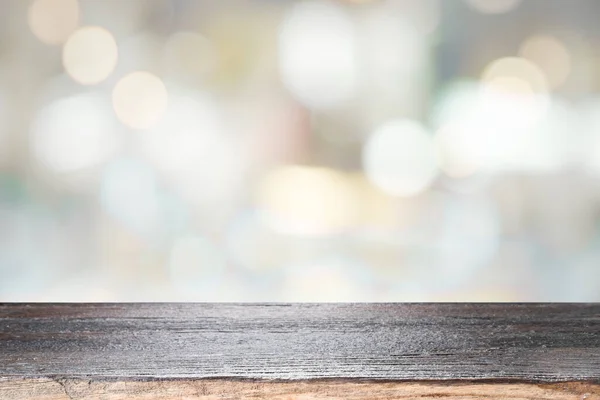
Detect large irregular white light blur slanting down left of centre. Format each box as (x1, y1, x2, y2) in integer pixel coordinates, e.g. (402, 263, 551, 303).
(139, 92, 245, 208)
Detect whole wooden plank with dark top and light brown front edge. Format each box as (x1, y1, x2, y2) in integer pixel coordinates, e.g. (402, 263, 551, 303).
(0, 303, 600, 400)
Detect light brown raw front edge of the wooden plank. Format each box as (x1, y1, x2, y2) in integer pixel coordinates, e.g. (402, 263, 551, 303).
(0, 378, 600, 400)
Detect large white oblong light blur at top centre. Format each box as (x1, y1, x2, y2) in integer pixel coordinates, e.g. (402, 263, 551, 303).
(279, 1, 357, 109)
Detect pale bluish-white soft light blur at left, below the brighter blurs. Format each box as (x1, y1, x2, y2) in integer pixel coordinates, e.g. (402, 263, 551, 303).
(100, 159, 160, 234)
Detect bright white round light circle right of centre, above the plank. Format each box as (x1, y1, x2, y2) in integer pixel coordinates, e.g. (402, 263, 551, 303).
(362, 119, 437, 196)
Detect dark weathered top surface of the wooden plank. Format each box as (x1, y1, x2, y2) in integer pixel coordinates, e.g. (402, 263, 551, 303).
(0, 303, 600, 383)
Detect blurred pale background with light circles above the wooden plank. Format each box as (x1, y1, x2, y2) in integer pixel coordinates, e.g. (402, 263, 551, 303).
(0, 0, 600, 301)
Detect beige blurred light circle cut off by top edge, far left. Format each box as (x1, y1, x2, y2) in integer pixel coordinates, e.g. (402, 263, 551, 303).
(27, 0, 79, 45)
